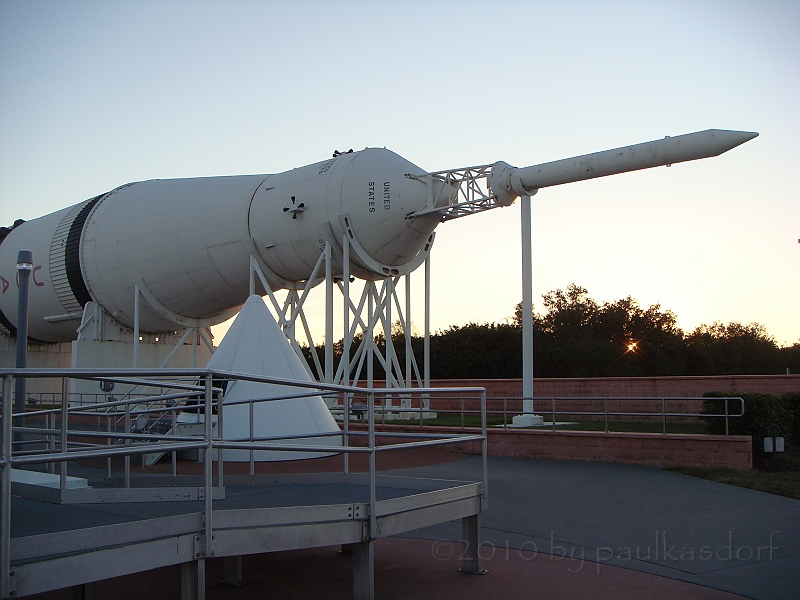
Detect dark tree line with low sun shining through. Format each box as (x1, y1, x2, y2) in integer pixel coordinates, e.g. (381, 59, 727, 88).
(304, 284, 800, 379)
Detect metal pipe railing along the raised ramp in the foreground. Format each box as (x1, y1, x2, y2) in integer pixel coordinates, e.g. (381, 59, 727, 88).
(0, 369, 488, 597)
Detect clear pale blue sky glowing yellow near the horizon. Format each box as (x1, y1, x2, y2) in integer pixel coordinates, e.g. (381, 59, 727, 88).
(0, 0, 800, 343)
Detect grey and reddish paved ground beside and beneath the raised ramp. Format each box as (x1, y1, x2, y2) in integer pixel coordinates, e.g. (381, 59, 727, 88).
(25, 453, 800, 600)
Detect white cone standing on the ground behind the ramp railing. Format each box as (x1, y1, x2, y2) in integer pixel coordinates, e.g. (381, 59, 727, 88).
(207, 295, 341, 461)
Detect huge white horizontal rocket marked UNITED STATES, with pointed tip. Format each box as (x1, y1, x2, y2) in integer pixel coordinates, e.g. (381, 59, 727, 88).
(0, 129, 758, 342)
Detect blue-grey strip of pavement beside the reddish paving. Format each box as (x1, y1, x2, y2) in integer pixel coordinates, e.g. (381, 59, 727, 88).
(392, 457, 800, 599)
